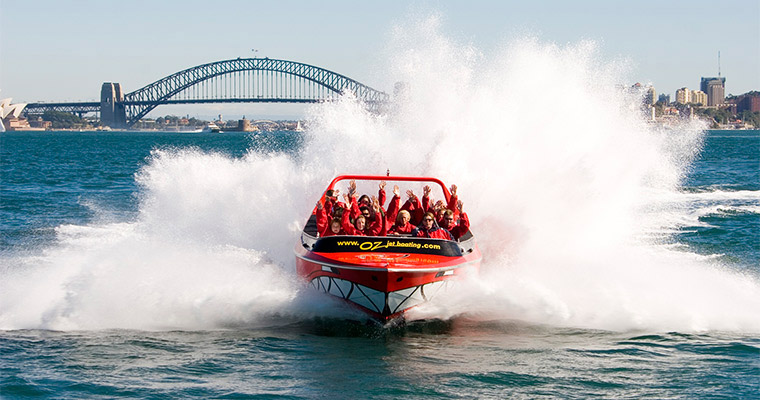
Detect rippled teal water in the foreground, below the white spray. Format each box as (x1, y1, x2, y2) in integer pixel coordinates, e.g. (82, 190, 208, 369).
(2, 320, 760, 399)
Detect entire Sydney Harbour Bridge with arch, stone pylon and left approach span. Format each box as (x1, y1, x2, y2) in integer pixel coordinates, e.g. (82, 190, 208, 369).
(24, 58, 389, 128)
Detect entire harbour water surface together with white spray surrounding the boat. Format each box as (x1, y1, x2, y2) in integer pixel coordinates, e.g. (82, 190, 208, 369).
(0, 24, 760, 399)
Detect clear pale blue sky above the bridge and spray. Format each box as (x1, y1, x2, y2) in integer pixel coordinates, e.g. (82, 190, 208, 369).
(0, 0, 760, 115)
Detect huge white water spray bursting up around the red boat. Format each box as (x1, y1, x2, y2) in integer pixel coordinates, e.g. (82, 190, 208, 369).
(0, 14, 760, 332)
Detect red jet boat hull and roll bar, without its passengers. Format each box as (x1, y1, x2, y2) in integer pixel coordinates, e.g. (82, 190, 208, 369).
(295, 175, 481, 321)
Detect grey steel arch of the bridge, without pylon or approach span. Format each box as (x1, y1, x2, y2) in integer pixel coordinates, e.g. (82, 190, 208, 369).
(121, 58, 389, 126)
